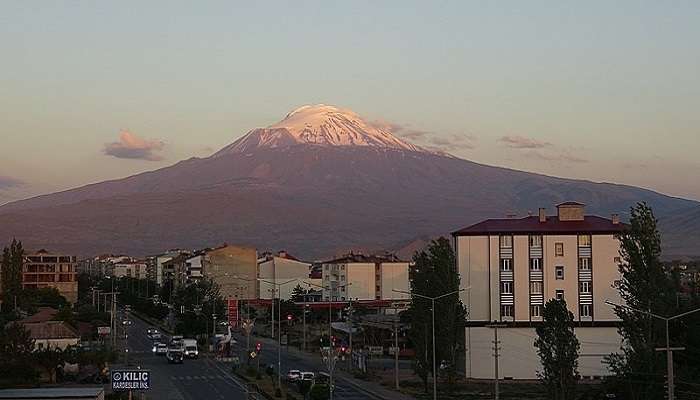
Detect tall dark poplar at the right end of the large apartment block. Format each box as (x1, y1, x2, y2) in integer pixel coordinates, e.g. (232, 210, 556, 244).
(608, 203, 677, 399)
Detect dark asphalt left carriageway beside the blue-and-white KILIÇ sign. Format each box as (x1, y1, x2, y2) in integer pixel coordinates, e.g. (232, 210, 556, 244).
(121, 317, 252, 400)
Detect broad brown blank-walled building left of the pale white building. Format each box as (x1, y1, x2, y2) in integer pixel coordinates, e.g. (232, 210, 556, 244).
(204, 246, 258, 299)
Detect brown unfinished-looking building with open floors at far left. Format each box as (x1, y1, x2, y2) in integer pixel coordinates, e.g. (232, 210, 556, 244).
(22, 250, 78, 303)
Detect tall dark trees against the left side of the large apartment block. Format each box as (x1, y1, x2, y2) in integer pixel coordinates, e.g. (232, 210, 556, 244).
(404, 237, 466, 391)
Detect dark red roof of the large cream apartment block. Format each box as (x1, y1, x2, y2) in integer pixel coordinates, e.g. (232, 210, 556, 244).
(452, 215, 626, 236)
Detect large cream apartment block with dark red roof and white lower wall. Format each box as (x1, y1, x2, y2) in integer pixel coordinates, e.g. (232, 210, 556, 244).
(452, 202, 624, 379)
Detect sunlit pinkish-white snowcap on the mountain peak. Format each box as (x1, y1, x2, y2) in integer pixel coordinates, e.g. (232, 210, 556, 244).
(214, 104, 427, 157)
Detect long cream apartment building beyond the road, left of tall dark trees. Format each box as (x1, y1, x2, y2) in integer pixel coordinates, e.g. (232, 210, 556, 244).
(321, 253, 410, 301)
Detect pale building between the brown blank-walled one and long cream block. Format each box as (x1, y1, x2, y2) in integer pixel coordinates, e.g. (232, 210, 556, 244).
(258, 251, 314, 300)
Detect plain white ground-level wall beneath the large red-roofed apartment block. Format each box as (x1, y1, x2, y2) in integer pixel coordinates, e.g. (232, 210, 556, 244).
(465, 327, 621, 379)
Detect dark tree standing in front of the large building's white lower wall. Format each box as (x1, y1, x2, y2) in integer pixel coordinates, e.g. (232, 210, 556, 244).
(535, 299, 580, 400)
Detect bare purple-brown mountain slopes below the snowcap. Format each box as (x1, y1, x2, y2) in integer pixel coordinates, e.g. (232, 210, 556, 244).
(0, 105, 700, 258)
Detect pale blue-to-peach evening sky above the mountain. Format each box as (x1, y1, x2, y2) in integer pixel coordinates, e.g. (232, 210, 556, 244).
(0, 0, 700, 204)
